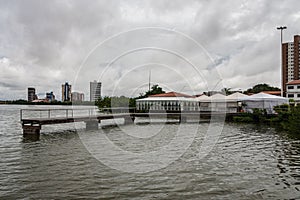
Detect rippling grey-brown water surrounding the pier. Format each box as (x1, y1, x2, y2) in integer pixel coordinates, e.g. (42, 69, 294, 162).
(0, 105, 300, 199)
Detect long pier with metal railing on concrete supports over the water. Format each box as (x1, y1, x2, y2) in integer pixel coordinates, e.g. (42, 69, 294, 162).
(20, 109, 238, 137)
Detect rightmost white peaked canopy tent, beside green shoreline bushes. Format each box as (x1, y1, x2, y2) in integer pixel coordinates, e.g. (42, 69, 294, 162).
(241, 92, 289, 114)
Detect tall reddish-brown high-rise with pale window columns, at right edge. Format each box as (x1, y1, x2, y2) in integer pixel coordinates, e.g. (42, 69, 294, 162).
(281, 35, 300, 96)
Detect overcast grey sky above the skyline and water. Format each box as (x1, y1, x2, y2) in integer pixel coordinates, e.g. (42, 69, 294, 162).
(0, 0, 300, 99)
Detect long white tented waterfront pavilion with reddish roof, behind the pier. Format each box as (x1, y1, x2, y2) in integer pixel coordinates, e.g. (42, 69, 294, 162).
(136, 91, 288, 114)
